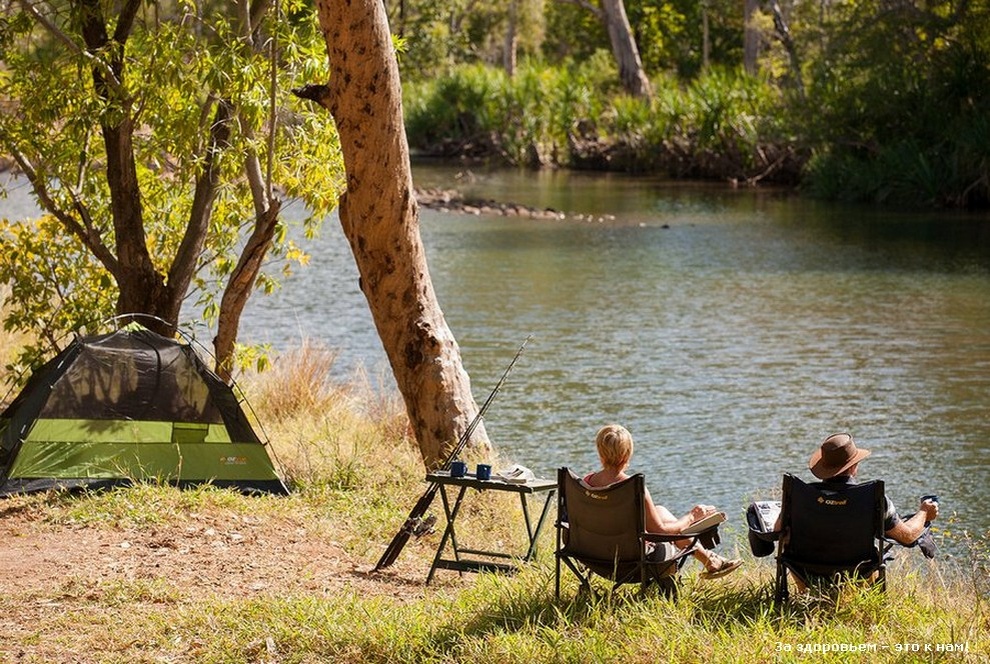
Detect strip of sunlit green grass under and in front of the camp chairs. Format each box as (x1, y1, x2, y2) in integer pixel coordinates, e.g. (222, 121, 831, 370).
(46, 564, 988, 664)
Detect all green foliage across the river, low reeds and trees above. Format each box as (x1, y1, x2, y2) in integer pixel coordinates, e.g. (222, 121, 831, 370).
(404, 0, 990, 207)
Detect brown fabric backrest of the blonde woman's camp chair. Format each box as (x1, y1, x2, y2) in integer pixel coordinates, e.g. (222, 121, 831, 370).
(557, 468, 646, 561)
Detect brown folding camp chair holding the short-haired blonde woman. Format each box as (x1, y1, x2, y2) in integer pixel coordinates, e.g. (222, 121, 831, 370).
(555, 468, 718, 599)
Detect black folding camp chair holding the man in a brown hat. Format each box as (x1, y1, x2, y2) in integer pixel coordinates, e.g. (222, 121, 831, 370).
(774, 474, 891, 605)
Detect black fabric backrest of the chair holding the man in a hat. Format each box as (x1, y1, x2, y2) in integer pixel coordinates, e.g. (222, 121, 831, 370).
(781, 474, 886, 569)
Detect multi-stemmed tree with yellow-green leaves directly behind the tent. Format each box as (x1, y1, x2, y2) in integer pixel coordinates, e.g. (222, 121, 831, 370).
(0, 0, 342, 377)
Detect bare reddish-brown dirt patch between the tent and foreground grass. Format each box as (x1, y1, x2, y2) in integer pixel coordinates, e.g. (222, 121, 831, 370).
(0, 506, 440, 599)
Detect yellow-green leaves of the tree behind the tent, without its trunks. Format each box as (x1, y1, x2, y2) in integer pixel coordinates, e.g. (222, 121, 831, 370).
(0, 1, 343, 374)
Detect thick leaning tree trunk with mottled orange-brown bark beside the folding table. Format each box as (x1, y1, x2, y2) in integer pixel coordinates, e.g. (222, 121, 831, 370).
(308, 0, 489, 468)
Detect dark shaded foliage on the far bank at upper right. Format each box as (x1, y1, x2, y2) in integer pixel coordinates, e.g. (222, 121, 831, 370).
(797, 2, 990, 206)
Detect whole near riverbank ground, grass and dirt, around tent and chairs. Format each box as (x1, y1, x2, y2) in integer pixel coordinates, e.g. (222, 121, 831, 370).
(0, 340, 990, 664)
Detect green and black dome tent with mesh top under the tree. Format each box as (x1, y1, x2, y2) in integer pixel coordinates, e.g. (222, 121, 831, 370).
(0, 326, 288, 496)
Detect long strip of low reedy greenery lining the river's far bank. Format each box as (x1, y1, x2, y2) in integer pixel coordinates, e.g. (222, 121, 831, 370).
(404, 58, 990, 208)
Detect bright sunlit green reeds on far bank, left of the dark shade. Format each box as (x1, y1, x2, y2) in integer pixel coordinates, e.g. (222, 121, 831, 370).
(406, 61, 786, 179)
